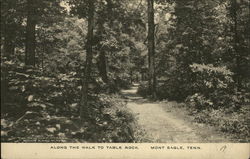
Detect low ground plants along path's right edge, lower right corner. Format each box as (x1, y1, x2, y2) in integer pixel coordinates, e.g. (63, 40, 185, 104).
(192, 106, 250, 142)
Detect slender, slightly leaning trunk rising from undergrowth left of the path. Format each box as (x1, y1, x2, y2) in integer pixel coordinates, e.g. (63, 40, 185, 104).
(80, 0, 95, 121)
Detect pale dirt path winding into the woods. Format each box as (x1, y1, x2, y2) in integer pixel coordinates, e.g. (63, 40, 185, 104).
(122, 85, 229, 143)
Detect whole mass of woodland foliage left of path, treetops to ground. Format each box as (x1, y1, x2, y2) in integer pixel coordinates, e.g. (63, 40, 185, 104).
(1, 0, 147, 142)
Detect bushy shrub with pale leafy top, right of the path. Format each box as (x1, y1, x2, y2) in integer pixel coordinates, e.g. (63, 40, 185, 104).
(186, 64, 240, 109)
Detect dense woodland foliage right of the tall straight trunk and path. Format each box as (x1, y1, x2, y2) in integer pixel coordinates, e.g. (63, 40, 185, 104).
(138, 0, 250, 138)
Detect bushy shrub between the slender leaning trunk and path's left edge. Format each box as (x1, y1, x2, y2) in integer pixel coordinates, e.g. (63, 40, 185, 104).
(85, 94, 138, 142)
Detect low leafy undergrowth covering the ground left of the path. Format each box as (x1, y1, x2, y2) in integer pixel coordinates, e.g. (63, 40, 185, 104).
(1, 61, 145, 143)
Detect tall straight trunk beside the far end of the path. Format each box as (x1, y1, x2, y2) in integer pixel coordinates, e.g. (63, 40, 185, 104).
(148, 0, 156, 98)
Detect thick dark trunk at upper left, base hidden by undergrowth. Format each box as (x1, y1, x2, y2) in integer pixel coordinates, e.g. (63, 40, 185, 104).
(25, 0, 36, 66)
